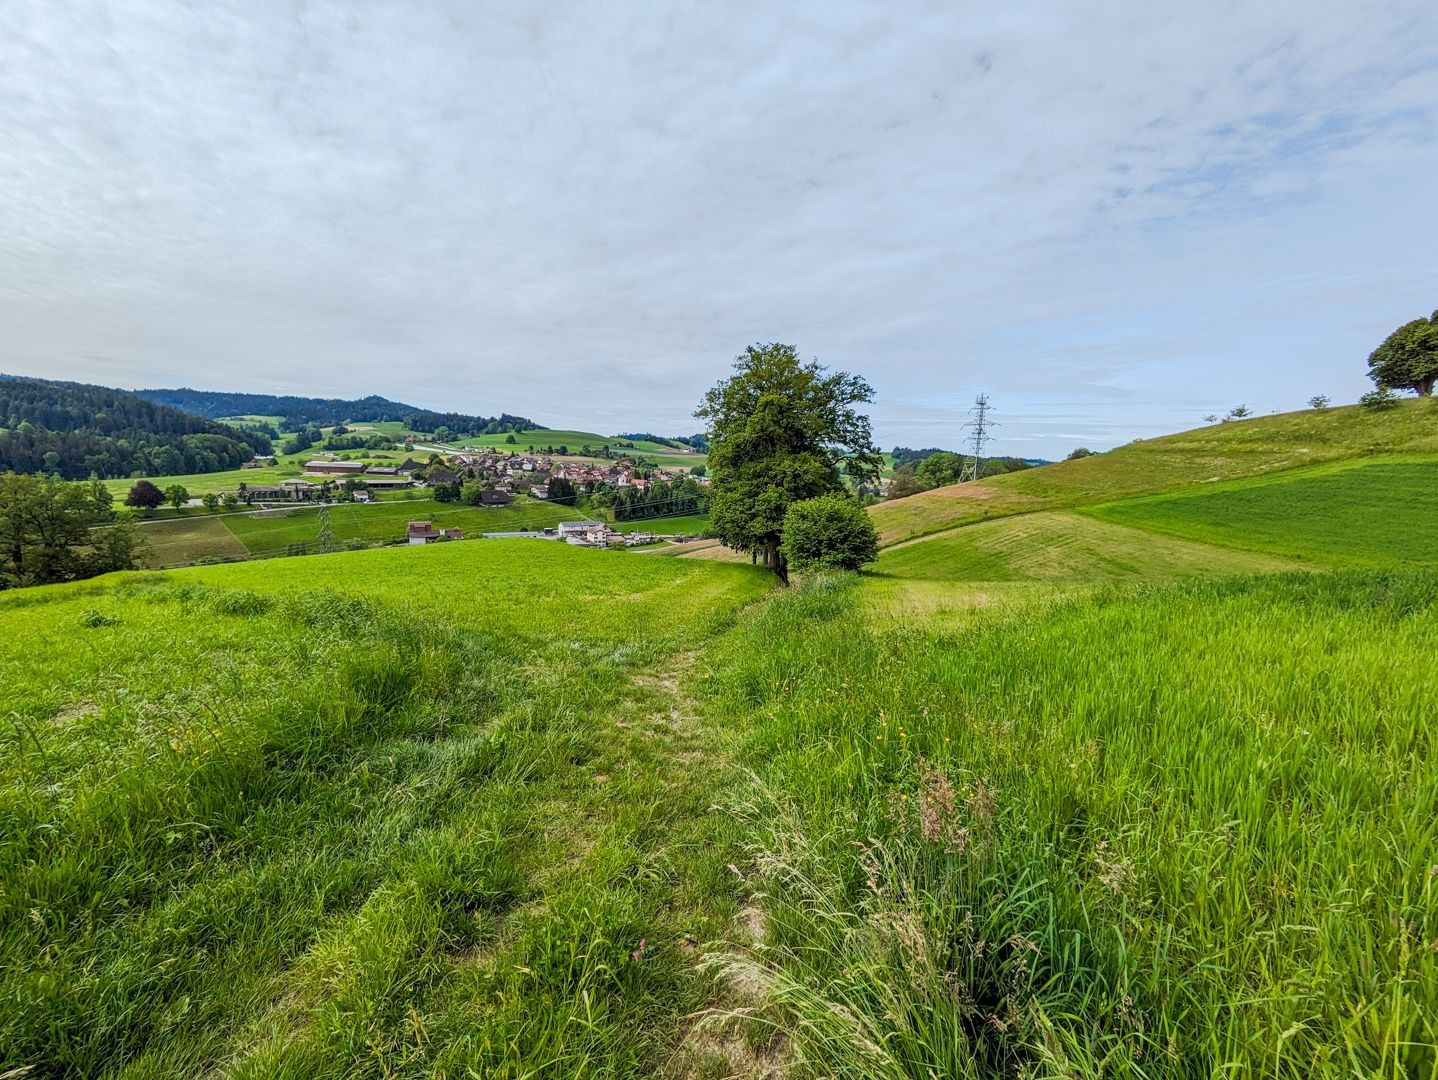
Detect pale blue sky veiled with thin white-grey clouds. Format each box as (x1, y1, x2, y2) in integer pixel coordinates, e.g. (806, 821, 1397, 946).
(0, 0, 1438, 457)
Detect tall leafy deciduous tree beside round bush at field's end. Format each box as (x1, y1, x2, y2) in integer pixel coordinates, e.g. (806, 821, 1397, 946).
(695, 344, 881, 584)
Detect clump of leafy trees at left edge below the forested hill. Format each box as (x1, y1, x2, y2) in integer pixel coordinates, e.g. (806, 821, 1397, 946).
(0, 472, 141, 588)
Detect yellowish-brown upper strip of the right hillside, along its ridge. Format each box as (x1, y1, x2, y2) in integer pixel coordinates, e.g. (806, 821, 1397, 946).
(871, 400, 1438, 545)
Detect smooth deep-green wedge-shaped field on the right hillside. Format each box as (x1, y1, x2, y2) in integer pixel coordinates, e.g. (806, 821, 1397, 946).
(1086, 457, 1438, 567)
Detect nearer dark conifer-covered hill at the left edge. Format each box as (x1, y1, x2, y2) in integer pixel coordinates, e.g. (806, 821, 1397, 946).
(0, 375, 270, 480)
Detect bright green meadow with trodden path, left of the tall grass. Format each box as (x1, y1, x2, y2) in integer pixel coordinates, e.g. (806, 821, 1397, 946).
(0, 542, 768, 1077)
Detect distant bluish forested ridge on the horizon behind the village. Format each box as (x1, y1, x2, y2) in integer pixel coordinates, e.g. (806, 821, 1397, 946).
(135, 387, 538, 434)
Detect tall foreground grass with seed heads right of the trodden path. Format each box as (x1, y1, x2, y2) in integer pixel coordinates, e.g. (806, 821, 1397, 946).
(706, 574, 1438, 1077)
